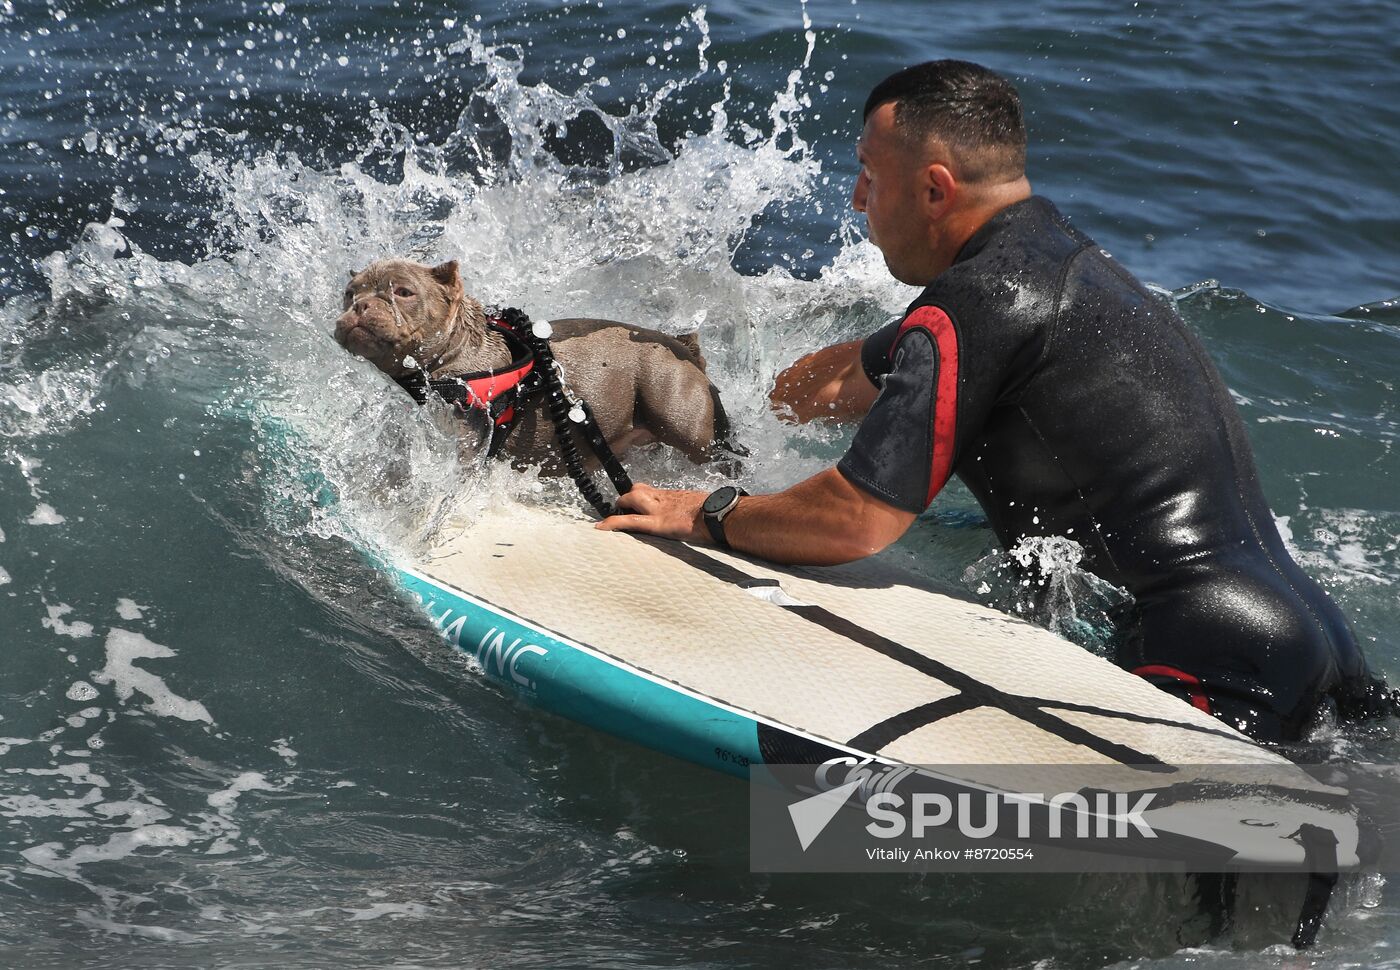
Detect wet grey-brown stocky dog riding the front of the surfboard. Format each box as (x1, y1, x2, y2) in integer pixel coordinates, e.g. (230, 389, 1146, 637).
(335, 259, 728, 466)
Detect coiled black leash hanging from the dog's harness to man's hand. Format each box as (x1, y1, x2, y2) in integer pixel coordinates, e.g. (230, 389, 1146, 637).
(497, 307, 631, 518)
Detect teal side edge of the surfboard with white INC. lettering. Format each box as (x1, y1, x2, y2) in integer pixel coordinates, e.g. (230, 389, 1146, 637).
(395, 565, 763, 778)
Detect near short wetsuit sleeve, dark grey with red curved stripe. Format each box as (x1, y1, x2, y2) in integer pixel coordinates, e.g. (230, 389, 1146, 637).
(836, 307, 958, 514)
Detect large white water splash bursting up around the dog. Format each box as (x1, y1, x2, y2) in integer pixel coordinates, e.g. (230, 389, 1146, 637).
(161, 8, 907, 559)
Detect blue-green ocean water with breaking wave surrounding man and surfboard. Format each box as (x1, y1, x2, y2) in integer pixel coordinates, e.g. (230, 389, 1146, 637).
(0, 0, 1400, 969)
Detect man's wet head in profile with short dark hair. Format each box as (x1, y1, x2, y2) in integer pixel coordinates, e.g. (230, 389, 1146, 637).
(851, 60, 1030, 286)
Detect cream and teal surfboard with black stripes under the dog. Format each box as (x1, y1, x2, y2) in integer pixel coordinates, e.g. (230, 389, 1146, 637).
(395, 505, 1361, 868)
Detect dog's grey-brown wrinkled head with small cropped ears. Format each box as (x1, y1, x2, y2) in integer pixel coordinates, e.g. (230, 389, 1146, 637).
(335, 259, 486, 377)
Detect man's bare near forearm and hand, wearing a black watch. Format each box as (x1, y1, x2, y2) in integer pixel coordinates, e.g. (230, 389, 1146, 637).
(598, 464, 916, 565)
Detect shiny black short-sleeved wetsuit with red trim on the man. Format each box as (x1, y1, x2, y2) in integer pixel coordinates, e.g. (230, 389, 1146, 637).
(839, 197, 1382, 740)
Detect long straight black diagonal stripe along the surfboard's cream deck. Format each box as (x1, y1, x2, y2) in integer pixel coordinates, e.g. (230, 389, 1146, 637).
(634, 535, 1175, 771)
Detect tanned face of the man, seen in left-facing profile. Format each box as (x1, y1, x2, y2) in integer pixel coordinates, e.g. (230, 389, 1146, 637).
(851, 102, 932, 286)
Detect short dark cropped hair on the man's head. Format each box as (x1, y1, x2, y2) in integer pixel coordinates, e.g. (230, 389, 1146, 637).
(864, 60, 1026, 182)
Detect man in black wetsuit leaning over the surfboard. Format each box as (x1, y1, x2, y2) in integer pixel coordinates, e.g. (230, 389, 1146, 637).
(599, 60, 1389, 742)
